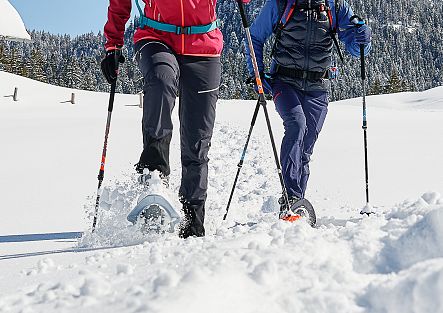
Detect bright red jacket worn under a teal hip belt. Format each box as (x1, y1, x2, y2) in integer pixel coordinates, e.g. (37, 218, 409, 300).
(104, 0, 223, 56)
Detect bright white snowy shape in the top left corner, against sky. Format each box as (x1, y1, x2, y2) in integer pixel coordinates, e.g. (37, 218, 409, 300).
(0, 0, 31, 40)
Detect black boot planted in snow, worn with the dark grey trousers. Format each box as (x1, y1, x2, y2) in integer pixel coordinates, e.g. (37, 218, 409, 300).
(178, 201, 205, 239)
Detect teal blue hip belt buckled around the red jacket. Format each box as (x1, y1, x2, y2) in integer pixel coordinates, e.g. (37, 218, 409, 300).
(135, 0, 221, 35)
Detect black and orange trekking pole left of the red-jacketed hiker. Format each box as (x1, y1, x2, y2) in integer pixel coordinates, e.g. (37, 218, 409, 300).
(92, 51, 119, 232)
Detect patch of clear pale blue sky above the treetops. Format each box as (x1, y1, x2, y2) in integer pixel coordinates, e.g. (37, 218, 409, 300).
(9, 0, 136, 36)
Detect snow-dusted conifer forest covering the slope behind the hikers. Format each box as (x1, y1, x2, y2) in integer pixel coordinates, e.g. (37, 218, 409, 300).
(0, 0, 443, 100)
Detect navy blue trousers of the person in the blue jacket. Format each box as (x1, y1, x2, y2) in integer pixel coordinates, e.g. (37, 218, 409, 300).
(272, 80, 328, 198)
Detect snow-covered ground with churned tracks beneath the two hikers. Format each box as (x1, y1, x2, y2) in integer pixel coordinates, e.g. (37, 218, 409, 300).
(0, 72, 443, 313)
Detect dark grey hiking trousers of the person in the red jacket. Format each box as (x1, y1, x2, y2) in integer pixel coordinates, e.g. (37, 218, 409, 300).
(135, 40, 221, 203)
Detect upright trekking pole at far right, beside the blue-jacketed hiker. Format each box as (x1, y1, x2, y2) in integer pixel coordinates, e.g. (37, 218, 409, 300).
(351, 15, 374, 215)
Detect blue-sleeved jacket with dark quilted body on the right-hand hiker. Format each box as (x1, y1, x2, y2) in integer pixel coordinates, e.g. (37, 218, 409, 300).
(246, 0, 371, 90)
